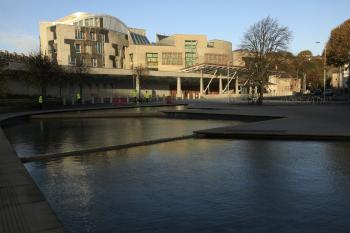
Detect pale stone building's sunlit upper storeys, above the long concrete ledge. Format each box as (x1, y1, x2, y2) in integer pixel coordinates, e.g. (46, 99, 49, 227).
(40, 12, 232, 71)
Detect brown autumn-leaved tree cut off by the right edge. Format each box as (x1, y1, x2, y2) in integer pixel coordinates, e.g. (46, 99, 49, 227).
(326, 19, 350, 67)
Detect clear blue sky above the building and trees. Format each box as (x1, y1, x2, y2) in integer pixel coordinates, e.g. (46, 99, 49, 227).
(0, 0, 350, 55)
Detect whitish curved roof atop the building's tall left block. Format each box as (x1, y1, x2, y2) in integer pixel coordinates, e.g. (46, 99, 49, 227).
(55, 12, 128, 34)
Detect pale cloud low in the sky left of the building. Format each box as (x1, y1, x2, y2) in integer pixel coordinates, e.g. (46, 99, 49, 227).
(0, 31, 39, 54)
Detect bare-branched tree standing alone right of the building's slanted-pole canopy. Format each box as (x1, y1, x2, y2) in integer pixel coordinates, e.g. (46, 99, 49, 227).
(241, 17, 292, 104)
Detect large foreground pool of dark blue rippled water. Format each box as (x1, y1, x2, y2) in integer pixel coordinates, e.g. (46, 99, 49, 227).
(26, 139, 350, 233)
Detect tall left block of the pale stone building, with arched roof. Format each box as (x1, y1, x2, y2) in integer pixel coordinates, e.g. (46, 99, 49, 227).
(40, 12, 129, 69)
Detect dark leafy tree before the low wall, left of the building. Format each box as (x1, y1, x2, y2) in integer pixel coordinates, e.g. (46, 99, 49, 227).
(27, 52, 62, 97)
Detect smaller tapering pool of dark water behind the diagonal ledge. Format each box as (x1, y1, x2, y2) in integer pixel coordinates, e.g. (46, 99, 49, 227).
(3, 117, 239, 157)
